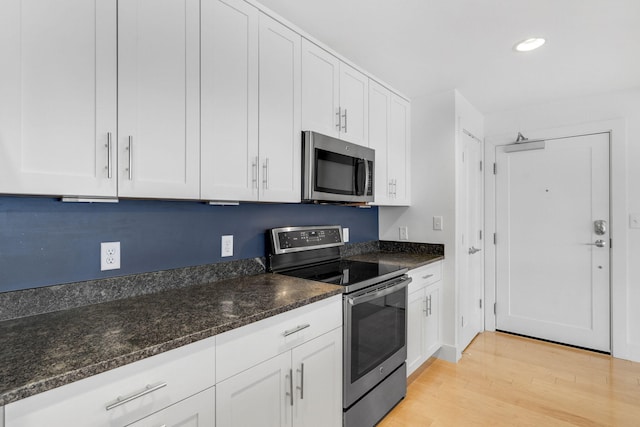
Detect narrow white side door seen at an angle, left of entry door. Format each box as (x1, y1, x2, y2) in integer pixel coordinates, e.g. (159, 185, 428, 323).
(458, 133, 484, 350)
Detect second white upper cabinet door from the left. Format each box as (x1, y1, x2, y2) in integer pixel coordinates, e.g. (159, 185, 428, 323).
(118, 0, 200, 199)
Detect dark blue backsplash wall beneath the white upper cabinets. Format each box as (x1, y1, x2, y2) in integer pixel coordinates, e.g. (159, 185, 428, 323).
(0, 197, 378, 292)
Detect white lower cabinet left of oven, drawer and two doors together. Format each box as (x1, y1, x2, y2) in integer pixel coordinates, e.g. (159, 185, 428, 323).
(216, 295, 342, 427)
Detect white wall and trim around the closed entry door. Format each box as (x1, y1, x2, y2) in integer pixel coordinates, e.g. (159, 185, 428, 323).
(485, 88, 640, 361)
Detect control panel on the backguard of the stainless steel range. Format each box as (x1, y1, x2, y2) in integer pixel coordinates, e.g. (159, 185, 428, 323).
(270, 225, 344, 254)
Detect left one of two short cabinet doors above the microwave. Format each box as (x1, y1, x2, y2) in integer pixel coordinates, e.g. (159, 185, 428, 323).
(302, 39, 340, 138)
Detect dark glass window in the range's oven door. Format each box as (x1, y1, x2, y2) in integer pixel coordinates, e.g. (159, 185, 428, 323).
(349, 287, 407, 383)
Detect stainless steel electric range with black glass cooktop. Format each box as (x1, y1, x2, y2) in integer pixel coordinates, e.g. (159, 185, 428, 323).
(267, 225, 411, 427)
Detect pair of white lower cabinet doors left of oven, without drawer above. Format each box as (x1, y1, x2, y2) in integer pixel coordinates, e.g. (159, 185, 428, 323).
(216, 328, 342, 427)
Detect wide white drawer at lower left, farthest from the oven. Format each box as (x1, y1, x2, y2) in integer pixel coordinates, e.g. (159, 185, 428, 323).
(5, 337, 215, 427)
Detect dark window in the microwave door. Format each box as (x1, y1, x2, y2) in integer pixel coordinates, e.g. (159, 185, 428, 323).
(315, 148, 357, 195)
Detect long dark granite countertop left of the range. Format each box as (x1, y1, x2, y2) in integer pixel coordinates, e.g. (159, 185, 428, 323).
(0, 274, 342, 406)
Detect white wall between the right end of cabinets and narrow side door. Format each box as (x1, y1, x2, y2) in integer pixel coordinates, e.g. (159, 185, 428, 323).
(379, 90, 483, 361)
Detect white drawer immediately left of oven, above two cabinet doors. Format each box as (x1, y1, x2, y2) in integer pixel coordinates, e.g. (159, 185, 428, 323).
(216, 295, 342, 381)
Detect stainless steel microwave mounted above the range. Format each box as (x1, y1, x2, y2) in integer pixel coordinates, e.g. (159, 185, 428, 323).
(302, 131, 375, 203)
